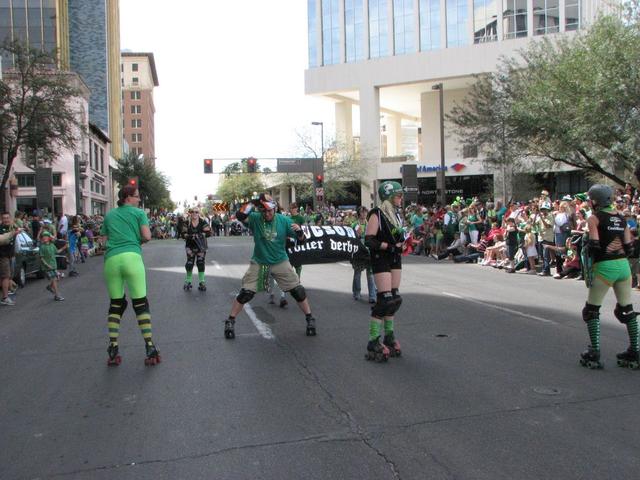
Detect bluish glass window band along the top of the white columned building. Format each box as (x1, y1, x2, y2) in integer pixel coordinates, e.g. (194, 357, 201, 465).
(308, 0, 589, 68)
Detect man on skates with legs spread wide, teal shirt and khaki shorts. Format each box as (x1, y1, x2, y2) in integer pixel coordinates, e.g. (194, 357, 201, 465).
(224, 193, 316, 339)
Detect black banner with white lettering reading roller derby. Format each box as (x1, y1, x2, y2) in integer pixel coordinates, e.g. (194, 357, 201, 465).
(287, 225, 369, 266)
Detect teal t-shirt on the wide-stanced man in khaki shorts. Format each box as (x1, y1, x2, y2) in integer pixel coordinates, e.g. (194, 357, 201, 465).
(247, 212, 295, 265)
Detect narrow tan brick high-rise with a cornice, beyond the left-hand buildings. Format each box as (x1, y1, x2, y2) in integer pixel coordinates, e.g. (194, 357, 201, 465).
(121, 52, 159, 166)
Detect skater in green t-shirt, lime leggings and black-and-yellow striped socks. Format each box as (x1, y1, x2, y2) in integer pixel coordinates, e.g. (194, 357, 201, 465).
(100, 185, 160, 365)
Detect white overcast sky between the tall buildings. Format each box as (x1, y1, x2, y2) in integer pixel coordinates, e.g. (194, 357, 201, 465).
(120, 0, 335, 203)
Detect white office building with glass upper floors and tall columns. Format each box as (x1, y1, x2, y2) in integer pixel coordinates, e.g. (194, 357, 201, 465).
(305, 0, 610, 205)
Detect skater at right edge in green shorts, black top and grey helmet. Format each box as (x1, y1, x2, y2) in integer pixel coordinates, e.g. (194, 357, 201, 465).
(580, 185, 640, 369)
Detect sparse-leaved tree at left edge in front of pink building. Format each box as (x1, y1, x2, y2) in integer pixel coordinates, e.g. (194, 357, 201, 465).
(0, 42, 85, 198)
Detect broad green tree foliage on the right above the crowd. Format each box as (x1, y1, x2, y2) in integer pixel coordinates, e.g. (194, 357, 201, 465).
(449, 7, 640, 185)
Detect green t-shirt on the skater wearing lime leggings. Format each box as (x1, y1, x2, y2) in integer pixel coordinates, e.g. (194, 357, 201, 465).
(100, 205, 149, 260)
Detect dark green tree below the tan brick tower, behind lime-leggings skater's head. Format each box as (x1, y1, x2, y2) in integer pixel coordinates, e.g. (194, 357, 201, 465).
(113, 152, 175, 210)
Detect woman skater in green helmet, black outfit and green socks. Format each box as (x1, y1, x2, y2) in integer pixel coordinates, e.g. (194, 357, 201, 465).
(365, 181, 407, 362)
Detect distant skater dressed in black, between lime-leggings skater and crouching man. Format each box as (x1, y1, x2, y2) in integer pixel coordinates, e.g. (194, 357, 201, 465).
(180, 208, 211, 292)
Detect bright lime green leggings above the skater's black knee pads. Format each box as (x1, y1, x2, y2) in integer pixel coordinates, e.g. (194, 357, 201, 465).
(104, 252, 147, 298)
